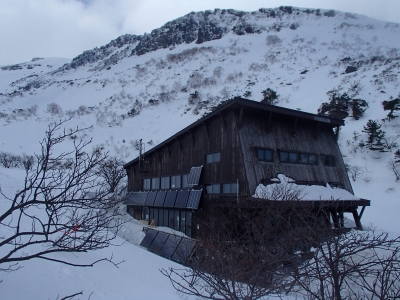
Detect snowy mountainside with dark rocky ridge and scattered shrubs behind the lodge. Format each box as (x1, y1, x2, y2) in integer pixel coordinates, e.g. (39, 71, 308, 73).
(0, 7, 400, 298)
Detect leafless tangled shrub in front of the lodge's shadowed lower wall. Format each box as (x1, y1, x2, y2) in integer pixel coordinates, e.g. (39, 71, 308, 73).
(162, 200, 326, 300)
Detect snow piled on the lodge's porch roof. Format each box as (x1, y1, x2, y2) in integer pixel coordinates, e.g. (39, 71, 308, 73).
(253, 174, 360, 201)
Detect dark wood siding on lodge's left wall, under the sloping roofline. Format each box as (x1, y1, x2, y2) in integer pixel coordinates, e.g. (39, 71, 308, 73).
(128, 111, 248, 195)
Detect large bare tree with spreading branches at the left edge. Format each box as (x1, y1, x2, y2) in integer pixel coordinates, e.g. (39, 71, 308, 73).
(0, 121, 121, 271)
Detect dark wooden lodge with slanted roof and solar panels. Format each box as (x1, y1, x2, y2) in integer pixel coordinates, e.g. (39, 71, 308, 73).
(124, 98, 370, 238)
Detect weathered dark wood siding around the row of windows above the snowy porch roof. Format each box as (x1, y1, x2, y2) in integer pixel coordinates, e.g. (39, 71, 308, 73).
(239, 112, 353, 194)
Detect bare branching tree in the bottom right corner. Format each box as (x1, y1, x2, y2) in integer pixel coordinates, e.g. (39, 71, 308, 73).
(295, 230, 400, 300)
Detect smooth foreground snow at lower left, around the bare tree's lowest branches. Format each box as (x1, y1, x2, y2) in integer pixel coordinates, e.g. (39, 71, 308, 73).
(0, 168, 188, 300)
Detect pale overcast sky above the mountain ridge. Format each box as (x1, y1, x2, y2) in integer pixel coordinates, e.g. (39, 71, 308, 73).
(0, 0, 400, 66)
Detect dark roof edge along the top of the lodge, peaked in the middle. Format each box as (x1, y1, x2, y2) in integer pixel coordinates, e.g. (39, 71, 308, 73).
(124, 97, 344, 168)
